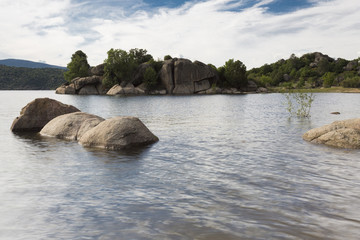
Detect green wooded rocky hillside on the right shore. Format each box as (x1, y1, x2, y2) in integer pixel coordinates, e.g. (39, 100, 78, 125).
(247, 52, 360, 89)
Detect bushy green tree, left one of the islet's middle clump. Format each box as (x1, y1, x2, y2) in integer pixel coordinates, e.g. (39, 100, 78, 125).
(103, 48, 138, 88)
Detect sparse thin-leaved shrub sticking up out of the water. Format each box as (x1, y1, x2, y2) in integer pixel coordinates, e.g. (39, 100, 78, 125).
(284, 92, 315, 118)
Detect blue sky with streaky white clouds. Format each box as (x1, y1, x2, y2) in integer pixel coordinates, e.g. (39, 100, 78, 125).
(0, 0, 360, 69)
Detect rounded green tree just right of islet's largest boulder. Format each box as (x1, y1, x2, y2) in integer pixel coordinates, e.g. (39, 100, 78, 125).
(224, 59, 247, 88)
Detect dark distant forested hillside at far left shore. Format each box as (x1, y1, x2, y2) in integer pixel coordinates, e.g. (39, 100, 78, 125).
(0, 65, 65, 90)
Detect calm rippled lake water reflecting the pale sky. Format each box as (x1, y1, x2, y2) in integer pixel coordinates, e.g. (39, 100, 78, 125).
(0, 91, 360, 240)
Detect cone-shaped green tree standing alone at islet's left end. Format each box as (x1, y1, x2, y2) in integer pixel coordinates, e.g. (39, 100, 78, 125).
(64, 50, 90, 82)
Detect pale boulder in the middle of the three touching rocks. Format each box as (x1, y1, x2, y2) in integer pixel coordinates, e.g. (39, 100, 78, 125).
(40, 112, 105, 140)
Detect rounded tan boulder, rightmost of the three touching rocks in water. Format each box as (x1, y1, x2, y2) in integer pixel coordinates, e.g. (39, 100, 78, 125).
(79, 117, 159, 150)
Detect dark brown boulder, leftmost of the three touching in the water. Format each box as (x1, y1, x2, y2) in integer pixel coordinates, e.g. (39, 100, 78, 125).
(11, 98, 80, 132)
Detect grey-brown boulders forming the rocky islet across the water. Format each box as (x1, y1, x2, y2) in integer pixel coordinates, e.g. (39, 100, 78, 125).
(56, 58, 267, 95)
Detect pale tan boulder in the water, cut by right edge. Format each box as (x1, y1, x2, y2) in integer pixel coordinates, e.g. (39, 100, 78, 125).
(303, 118, 360, 149)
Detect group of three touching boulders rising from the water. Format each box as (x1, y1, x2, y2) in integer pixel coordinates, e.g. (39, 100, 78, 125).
(11, 98, 159, 150)
